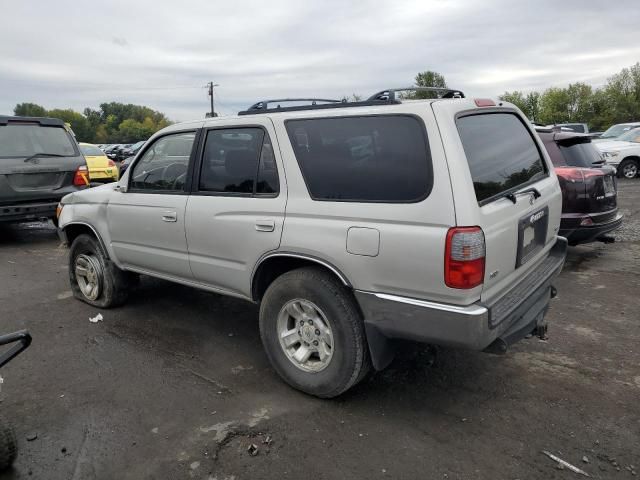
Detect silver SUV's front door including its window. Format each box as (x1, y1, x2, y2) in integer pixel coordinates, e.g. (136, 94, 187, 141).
(107, 131, 196, 280)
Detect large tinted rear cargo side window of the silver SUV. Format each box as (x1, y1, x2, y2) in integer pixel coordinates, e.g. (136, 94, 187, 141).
(286, 115, 432, 202)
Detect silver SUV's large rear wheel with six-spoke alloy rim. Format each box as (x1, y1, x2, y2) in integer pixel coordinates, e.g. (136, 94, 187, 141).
(260, 268, 370, 398)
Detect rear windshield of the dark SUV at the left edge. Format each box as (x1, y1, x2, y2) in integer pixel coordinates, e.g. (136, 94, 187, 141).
(0, 123, 77, 158)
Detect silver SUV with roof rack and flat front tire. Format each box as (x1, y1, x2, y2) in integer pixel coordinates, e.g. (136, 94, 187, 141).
(59, 89, 566, 397)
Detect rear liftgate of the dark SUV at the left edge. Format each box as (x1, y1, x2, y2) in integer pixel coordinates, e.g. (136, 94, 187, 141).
(0, 120, 85, 205)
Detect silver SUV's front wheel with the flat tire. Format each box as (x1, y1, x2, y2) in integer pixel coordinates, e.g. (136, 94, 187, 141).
(69, 234, 133, 308)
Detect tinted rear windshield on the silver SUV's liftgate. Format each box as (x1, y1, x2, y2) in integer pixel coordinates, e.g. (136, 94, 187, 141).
(457, 113, 547, 205)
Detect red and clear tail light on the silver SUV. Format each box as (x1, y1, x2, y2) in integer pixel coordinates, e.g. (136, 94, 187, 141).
(444, 227, 485, 289)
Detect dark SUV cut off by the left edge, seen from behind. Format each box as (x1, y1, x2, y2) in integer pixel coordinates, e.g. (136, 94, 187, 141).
(0, 116, 89, 222)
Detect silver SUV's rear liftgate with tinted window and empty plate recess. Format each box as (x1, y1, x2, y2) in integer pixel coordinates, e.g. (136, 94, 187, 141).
(433, 100, 562, 302)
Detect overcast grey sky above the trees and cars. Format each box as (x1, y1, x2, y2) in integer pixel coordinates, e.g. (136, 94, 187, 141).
(0, 0, 640, 121)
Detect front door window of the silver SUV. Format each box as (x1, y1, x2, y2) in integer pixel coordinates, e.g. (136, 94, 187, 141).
(131, 132, 195, 191)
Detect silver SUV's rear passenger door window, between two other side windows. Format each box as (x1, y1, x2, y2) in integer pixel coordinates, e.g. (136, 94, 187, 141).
(199, 128, 279, 194)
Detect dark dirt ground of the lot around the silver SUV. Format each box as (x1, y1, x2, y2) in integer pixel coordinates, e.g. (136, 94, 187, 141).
(0, 179, 640, 480)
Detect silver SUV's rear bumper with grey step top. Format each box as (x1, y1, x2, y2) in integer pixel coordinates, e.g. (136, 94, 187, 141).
(355, 237, 567, 368)
